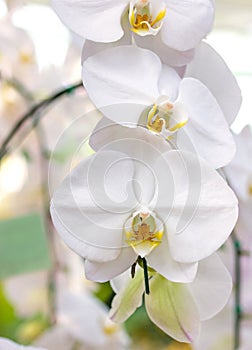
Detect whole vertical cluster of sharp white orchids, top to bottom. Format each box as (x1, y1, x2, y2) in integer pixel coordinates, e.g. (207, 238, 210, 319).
(51, 0, 241, 343)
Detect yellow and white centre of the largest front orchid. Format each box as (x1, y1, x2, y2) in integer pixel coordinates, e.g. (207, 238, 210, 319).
(124, 211, 164, 257)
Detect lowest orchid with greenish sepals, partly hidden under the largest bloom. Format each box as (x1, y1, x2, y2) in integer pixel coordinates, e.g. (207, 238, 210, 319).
(110, 254, 232, 343)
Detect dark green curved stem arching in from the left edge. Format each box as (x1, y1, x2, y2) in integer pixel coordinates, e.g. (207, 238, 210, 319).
(0, 82, 83, 160)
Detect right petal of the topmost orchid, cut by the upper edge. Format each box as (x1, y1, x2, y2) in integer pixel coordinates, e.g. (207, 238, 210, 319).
(160, 0, 214, 51)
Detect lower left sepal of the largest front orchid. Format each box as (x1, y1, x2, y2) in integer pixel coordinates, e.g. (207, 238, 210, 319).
(85, 247, 137, 282)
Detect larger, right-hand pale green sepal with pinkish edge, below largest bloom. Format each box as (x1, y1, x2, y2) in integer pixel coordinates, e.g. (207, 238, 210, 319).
(145, 274, 200, 343)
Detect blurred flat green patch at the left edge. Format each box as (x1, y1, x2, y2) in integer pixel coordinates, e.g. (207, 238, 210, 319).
(0, 214, 51, 279)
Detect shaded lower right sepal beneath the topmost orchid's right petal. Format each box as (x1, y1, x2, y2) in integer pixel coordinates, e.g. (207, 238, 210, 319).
(134, 34, 194, 67)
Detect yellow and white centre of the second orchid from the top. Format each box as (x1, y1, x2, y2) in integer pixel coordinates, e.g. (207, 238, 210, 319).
(147, 99, 188, 137)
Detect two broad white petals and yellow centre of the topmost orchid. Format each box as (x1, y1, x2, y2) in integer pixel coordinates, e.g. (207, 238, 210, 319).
(52, 0, 214, 51)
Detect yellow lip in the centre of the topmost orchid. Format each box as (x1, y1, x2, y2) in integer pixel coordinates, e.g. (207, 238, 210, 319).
(129, 2, 166, 35)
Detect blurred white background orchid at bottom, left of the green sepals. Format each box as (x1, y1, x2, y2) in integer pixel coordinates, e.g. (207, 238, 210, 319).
(36, 290, 130, 350)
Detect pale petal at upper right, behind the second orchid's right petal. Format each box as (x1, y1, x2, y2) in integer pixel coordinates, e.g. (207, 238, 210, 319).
(186, 42, 242, 125)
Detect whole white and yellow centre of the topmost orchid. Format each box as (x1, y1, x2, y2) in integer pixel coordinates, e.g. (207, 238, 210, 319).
(129, 0, 166, 36)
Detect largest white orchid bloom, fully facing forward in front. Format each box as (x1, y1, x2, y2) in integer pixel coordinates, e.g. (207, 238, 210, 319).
(51, 128, 237, 282)
